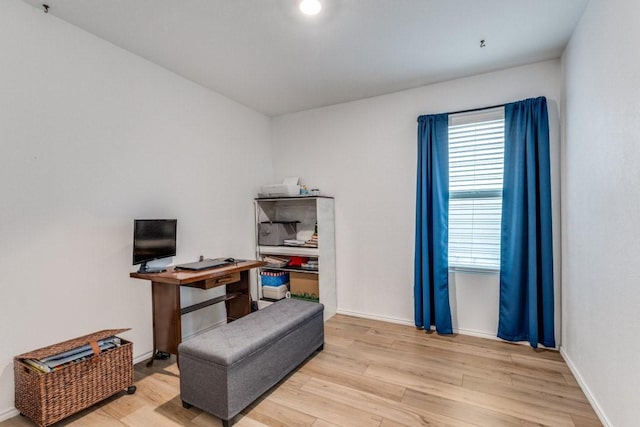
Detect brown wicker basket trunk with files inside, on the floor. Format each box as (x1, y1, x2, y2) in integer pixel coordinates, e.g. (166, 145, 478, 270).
(13, 329, 135, 426)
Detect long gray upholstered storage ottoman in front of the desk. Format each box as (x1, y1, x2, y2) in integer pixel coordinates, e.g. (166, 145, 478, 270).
(178, 299, 324, 426)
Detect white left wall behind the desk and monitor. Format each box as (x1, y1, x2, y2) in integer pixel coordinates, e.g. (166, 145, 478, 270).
(0, 0, 272, 419)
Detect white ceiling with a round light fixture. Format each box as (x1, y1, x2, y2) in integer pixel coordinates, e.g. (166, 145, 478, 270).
(24, 0, 588, 116)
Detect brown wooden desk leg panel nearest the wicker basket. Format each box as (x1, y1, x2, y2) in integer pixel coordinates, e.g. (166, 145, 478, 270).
(147, 282, 182, 366)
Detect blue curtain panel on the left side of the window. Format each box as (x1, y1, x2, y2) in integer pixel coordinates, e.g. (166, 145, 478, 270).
(413, 114, 453, 334)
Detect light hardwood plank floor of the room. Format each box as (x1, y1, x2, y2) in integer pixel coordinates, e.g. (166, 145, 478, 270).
(0, 315, 602, 427)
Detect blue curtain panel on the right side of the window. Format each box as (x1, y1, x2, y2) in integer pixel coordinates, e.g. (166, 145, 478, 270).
(498, 97, 555, 348)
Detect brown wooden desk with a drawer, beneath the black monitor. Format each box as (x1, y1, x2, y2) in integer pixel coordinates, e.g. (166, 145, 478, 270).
(129, 260, 267, 366)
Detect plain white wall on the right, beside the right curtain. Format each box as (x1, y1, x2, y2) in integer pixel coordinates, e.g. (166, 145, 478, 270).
(562, 0, 640, 427)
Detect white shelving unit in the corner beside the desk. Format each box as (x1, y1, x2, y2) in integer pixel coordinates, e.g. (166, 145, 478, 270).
(255, 196, 337, 320)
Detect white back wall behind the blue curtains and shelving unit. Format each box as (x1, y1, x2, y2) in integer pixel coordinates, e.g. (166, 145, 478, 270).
(273, 60, 561, 340)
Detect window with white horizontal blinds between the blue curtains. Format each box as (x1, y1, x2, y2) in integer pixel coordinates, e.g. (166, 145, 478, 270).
(449, 107, 504, 270)
